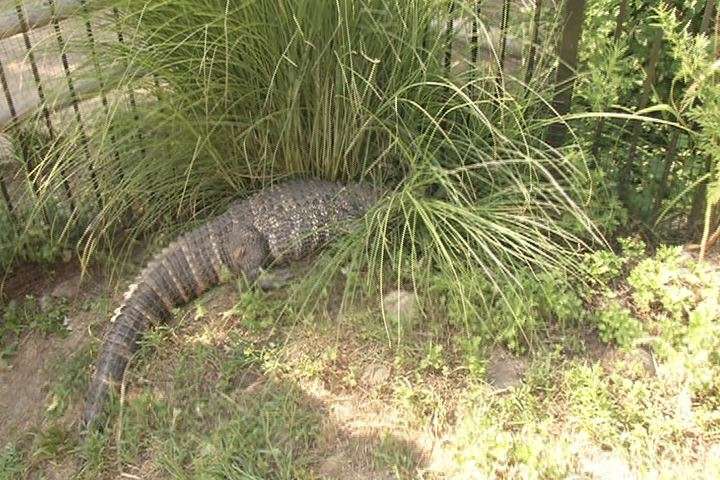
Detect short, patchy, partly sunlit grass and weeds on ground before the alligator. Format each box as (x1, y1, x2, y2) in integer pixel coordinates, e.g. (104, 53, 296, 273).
(3, 245, 720, 479)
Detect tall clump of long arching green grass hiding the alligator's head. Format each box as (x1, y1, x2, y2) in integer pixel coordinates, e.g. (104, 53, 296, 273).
(29, 0, 602, 350)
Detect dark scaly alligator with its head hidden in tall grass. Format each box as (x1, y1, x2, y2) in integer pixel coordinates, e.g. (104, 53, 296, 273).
(82, 179, 379, 427)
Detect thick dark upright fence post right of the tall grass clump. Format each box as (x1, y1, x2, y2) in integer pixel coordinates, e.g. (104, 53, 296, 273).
(547, 0, 585, 147)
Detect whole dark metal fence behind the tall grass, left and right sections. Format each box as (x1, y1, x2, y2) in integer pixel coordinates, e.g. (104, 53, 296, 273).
(0, 0, 712, 236)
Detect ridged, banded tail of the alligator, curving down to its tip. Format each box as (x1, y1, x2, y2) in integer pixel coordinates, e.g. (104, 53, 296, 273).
(83, 215, 267, 426)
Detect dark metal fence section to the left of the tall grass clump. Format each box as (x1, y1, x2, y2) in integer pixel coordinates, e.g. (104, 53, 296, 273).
(0, 0, 124, 221)
